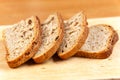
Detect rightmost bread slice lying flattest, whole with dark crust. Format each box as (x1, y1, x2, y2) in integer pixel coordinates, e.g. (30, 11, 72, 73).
(76, 24, 118, 59)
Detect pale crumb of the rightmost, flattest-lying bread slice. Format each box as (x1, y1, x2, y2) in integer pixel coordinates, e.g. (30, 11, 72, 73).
(80, 26, 111, 52)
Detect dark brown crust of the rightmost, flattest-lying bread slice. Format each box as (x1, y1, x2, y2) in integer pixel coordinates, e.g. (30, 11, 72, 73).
(75, 24, 119, 59)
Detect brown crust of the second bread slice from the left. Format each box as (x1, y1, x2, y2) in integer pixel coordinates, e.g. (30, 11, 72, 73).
(33, 13, 64, 63)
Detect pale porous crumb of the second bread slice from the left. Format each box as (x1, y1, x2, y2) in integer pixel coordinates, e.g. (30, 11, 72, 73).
(35, 15, 59, 57)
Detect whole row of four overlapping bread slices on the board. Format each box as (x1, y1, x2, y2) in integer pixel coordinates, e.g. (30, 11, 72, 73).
(3, 12, 118, 68)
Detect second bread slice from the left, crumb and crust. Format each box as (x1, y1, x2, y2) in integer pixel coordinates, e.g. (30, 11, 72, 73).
(33, 13, 64, 63)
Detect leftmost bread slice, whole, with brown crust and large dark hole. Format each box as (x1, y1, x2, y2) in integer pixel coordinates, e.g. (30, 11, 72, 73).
(3, 16, 41, 68)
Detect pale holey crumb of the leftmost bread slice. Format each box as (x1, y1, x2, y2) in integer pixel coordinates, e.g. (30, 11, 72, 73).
(5, 19, 34, 60)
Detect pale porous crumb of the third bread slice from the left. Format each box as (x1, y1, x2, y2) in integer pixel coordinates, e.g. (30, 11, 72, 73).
(59, 13, 82, 53)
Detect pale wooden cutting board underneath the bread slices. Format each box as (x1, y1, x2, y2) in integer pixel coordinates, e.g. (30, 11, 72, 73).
(0, 17, 120, 80)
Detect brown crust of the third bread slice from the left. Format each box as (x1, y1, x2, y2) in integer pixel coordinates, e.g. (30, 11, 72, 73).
(57, 12, 89, 59)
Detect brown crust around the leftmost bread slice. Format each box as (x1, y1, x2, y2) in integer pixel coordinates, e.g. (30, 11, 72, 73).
(3, 16, 41, 68)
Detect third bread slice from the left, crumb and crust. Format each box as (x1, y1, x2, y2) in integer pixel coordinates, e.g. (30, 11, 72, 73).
(57, 12, 88, 59)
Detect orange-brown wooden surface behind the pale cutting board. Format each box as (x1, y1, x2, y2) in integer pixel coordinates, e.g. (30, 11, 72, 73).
(0, 0, 120, 25)
